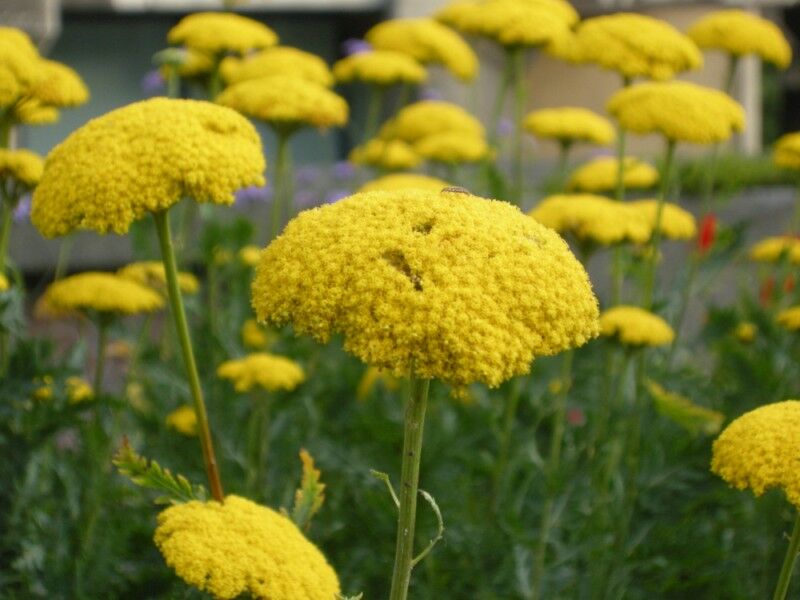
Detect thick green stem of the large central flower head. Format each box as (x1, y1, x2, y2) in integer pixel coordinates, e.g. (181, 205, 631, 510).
(389, 374, 430, 600)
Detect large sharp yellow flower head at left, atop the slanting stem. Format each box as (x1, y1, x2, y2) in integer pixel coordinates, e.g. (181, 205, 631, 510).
(31, 98, 265, 237)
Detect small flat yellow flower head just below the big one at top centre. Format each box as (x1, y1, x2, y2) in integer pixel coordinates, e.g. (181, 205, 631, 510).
(333, 50, 428, 85)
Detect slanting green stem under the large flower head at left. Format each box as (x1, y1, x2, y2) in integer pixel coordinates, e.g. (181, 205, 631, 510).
(153, 211, 224, 502)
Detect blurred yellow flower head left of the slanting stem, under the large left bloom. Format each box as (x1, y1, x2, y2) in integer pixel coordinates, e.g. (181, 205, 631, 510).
(45, 271, 164, 315)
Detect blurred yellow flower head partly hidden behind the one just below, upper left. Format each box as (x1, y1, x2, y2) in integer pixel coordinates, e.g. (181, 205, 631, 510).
(220, 46, 333, 87)
